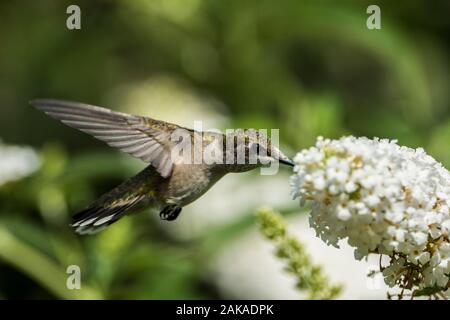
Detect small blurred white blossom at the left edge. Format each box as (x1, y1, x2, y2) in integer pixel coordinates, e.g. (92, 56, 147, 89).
(0, 140, 41, 186)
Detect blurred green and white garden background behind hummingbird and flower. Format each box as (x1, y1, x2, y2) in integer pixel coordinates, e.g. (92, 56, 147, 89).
(0, 0, 450, 299)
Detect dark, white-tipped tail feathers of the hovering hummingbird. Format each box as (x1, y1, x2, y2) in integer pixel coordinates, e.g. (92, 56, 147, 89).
(71, 170, 152, 234)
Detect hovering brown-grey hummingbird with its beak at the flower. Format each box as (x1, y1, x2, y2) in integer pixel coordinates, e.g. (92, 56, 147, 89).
(30, 99, 294, 234)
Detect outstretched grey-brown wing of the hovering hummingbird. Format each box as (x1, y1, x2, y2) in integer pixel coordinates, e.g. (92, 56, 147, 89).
(30, 99, 190, 178)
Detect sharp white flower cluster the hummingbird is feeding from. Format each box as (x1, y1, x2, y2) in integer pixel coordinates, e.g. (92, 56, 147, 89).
(291, 136, 450, 289)
